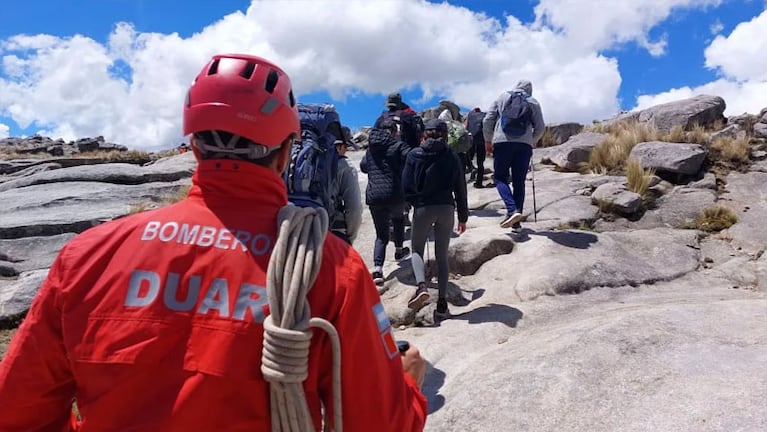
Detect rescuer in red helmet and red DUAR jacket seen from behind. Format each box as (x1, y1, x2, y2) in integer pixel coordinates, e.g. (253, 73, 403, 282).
(0, 55, 426, 432)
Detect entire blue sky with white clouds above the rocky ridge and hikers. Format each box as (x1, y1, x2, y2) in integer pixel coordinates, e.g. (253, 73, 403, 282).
(0, 0, 767, 149)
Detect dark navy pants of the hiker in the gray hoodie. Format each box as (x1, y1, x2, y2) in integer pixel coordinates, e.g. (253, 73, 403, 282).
(493, 142, 533, 214)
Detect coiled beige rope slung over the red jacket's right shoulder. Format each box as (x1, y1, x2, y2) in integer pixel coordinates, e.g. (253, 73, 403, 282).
(261, 205, 343, 432)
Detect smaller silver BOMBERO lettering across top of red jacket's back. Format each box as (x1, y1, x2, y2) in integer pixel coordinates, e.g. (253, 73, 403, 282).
(141, 221, 272, 255)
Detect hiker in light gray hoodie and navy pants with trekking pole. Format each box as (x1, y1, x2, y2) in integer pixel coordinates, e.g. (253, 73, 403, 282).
(482, 79, 546, 228)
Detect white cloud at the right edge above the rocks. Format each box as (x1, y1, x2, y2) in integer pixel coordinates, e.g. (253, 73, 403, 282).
(636, 10, 767, 115)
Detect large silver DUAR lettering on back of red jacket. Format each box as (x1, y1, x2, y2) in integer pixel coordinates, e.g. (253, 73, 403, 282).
(125, 269, 269, 323)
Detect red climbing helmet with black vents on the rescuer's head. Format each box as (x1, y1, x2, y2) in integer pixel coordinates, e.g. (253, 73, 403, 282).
(184, 54, 301, 147)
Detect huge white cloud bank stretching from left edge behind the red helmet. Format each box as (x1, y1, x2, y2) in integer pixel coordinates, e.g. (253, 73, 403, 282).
(0, 0, 752, 149)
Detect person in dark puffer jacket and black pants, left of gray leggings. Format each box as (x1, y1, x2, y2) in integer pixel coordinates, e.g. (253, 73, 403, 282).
(360, 121, 410, 285)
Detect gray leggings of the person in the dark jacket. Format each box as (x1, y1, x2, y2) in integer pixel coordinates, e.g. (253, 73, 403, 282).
(410, 204, 455, 298)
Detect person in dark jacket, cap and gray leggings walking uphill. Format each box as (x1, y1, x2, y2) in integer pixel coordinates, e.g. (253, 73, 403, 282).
(402, 119, 469, 319)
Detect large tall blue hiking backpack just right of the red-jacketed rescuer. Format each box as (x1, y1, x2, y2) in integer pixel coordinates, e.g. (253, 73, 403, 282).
(283, 104, 343, 215)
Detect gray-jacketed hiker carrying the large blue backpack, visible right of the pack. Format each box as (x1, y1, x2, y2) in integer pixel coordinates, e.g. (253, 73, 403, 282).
(330, 136, 362, 244)
